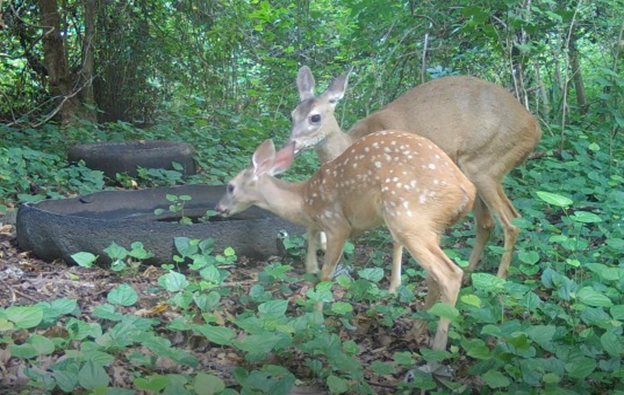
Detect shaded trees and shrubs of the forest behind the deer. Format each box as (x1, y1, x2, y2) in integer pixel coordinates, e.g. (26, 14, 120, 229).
(0, 0, 624, 155)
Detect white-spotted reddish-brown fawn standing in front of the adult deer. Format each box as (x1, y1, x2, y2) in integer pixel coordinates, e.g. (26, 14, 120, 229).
(216, 131, 475, 350)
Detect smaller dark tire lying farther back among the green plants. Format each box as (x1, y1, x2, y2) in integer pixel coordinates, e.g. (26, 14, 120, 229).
(67, 140, 196, 178)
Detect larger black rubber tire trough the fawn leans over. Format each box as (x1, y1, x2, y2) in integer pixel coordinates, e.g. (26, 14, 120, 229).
(16, 185, 305, 264)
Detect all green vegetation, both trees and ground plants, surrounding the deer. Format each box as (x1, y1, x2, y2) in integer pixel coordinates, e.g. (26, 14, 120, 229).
(0, 0, 624, 395)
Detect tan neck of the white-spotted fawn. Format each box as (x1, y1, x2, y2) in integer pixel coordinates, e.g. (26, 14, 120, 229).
(256, 177, 312, 226)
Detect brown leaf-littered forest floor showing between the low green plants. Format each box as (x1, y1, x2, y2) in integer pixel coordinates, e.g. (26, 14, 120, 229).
(0, 217, 478, 394)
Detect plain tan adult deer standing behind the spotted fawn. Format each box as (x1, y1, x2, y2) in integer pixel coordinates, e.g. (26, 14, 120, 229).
(287, 66, 542, 280)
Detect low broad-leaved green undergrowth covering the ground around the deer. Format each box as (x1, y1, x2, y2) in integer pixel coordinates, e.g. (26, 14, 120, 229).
(0, 114, 624, 395)
